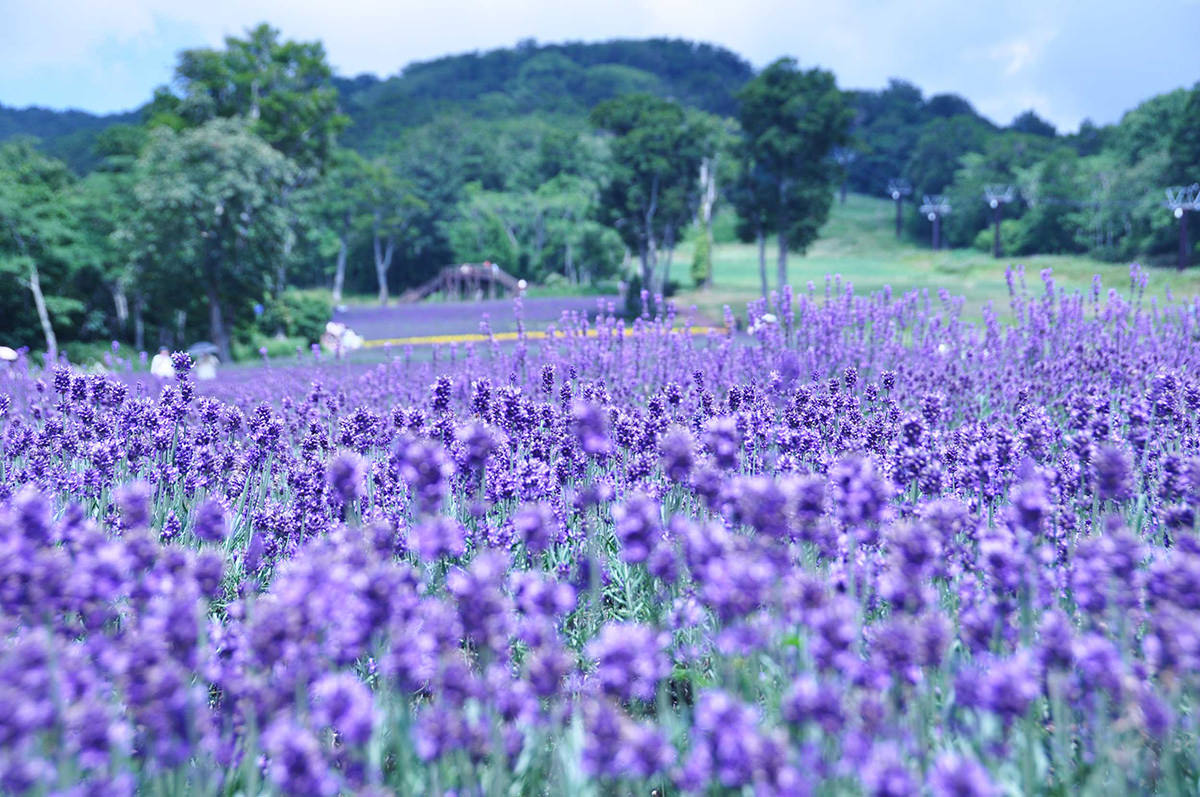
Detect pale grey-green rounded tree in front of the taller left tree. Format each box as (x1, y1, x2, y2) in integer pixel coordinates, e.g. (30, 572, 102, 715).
(134, 119, 296, 360)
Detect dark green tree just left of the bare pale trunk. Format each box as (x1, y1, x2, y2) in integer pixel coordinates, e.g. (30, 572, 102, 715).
(592, 94, 701, 293)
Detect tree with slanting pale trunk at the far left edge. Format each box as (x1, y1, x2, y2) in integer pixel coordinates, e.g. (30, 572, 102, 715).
(0, 139, 82, 360)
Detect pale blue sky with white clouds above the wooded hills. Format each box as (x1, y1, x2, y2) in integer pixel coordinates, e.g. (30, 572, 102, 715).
(0, 0, 1200, 132)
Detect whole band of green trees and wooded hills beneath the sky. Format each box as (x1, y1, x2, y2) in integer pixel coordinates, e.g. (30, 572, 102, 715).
(0, 25, 1200, 356)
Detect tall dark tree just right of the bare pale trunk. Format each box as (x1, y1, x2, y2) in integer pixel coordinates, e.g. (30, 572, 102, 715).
(737, 58, 852, 287)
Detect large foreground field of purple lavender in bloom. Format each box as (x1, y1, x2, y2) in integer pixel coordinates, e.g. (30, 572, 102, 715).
(0, 266, 1200, 797)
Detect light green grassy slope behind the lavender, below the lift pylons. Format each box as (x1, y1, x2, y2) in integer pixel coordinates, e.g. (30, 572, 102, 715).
(672, 194, 1200, 318)
